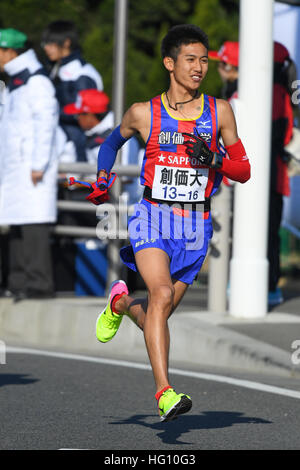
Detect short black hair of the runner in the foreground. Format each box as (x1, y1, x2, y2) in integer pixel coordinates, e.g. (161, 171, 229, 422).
(161, 24, 209, 61)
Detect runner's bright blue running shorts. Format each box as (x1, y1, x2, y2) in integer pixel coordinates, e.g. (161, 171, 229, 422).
(120, 199, 213, 284)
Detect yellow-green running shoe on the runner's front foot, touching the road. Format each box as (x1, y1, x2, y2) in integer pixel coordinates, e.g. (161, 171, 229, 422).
(158, 388, 192, 421)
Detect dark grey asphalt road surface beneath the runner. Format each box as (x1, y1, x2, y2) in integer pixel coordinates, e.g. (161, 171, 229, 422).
(0, 352, 300, 452)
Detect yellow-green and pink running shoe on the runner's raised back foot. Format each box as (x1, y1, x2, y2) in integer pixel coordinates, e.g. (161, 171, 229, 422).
(96, 281, 128, 343)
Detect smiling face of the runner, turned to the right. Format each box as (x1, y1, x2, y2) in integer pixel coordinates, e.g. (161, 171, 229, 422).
(169, 42, 208, 90)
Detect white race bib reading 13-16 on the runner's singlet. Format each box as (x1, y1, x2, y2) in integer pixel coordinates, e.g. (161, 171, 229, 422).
(152, 165, 209, 202)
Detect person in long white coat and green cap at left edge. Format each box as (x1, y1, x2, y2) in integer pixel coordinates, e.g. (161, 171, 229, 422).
(0, 28, 59, 300)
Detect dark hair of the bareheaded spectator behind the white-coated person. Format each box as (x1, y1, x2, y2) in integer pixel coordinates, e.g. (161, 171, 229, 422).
(42, 20, 79, 51)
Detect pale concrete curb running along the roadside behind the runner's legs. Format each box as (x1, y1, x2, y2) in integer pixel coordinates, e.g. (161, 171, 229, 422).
(0, 299, 300, 377)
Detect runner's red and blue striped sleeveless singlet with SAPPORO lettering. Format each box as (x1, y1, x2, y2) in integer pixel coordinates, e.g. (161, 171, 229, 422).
(140, 93, 224, 203)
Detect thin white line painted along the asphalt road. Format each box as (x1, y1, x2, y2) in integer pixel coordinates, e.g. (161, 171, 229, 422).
(6, 347, 300, 400)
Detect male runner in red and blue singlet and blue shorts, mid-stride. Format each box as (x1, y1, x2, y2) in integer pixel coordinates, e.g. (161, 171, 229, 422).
(89, 25, 250, 421)
